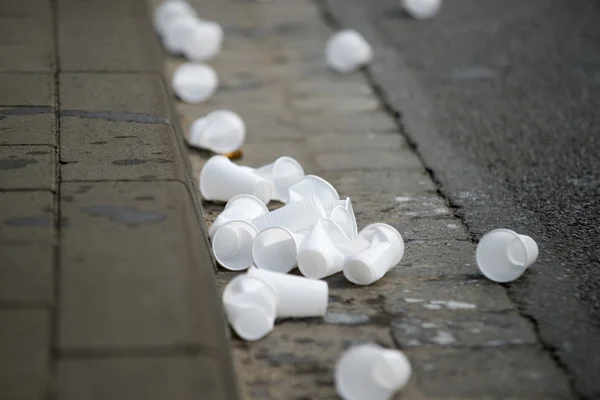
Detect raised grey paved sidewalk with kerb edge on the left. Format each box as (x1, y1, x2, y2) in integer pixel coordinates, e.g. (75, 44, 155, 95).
(0, 0, 237, 400)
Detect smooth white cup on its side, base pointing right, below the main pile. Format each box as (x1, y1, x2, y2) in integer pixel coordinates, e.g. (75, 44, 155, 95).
(248, 267, 329, 317)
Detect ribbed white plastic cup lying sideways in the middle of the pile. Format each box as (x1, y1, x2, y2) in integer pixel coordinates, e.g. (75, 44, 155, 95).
(250, 196, 325, 232)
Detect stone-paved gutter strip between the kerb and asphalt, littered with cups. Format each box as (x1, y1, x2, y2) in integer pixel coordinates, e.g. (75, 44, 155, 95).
(166, 0, 575, 400)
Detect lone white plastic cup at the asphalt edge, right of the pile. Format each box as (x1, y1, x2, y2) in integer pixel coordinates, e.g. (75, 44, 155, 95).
(475, 229, 539, 282)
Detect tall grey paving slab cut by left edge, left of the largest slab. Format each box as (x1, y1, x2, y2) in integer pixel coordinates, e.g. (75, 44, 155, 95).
(0, 192, 54, 304)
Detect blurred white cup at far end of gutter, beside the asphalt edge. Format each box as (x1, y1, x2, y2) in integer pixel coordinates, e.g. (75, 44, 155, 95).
(325, 29, 373, 73)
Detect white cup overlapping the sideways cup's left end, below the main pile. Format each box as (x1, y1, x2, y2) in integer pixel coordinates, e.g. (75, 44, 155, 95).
(223, 275, 279, 341)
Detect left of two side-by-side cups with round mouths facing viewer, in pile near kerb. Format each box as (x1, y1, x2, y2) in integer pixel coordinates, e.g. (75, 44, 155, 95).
(212, 221, 258, 271)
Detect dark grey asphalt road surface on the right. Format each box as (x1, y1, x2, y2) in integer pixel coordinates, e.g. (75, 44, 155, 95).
(324, 0, 600, 399)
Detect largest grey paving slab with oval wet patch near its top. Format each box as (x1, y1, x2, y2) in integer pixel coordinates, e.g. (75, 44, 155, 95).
(58, 182, 226, 351)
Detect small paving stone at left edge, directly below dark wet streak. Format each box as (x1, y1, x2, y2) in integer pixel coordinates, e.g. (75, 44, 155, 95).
(0, 108, 56, 146)
